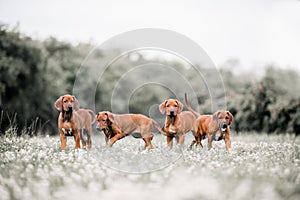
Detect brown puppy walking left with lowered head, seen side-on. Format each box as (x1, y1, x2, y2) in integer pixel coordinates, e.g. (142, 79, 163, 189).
(96, 111, 163, 149)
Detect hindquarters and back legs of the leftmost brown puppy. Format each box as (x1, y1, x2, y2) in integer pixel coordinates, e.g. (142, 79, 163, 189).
(77, 109, 96, 149)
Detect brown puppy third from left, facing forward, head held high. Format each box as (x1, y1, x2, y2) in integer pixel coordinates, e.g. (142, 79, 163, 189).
(159, 99, 197, 148)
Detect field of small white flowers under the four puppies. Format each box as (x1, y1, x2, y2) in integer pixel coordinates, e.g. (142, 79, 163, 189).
(0, 129, 300, 200)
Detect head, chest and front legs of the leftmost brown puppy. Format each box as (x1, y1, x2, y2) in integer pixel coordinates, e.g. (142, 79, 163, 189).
(54, 94, 81, 150)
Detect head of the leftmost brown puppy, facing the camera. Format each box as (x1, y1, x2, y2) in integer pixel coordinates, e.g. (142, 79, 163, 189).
(54, 94, 79, 112)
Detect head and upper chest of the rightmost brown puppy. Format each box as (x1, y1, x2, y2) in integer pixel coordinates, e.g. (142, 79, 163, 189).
(213, 110, 233, 140)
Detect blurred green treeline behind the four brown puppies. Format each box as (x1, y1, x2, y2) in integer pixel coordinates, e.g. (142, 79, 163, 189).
(0, 25, 300, 134)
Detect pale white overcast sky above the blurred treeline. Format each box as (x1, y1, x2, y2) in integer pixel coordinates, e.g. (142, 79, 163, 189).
(0, 0, 300, 71)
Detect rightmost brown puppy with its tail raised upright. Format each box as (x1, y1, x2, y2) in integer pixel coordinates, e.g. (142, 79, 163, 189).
(185, 94, 233, 151)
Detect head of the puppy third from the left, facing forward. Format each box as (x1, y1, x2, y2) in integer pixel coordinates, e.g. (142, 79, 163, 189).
(159, 99, 183, 116)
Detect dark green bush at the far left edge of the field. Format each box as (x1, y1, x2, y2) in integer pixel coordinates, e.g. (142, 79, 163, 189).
(0, 26, 43, 134)
